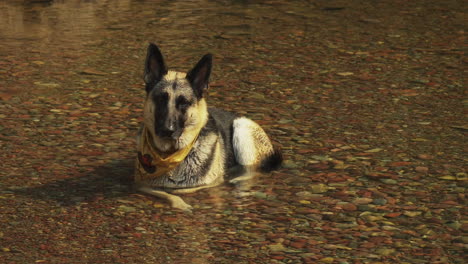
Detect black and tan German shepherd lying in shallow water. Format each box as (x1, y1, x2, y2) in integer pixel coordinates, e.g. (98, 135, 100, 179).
(135, 43, 282, 210)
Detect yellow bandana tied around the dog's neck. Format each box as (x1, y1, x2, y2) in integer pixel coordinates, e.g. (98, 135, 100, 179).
(135, 126, 198, 182)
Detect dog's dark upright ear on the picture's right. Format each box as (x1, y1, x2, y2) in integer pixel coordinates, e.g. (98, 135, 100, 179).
(186, 54, 213, 98)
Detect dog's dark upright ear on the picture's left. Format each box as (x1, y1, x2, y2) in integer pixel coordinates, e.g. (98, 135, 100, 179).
(144, 43, 167, 93)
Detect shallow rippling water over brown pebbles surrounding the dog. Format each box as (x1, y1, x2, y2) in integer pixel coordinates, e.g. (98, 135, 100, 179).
(0, 0, 467, 263)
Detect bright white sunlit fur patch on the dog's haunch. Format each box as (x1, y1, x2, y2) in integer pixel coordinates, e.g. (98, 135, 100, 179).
(232, 117, 258, 166)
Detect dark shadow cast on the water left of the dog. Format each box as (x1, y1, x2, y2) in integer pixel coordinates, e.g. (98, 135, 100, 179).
(14, 160, 134, 206)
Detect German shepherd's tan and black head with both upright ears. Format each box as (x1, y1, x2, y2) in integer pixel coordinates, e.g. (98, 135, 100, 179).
(144, 43, 212, 152)
